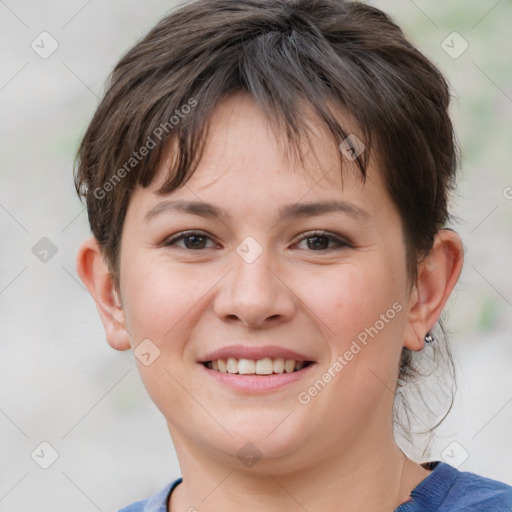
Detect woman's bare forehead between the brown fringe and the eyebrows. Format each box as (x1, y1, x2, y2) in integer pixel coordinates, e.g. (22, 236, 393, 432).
(138, 94, 386, 224)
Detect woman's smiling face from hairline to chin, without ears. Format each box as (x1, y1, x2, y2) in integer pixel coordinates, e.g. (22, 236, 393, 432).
(120, 95, 418, 468)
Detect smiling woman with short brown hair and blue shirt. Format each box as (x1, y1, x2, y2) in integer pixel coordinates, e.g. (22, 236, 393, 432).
(76, 0, 512, 512)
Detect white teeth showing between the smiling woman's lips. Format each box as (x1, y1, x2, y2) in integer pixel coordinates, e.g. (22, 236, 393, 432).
(202, 357, 314, 375)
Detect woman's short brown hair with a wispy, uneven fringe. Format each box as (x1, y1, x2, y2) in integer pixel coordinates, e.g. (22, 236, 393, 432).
(75, 0, 458, 450)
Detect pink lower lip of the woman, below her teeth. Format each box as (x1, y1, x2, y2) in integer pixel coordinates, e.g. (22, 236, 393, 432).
(199, 363, 315, 394)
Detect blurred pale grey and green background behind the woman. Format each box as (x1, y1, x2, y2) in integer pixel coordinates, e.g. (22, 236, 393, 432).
(0, 0, 512, 512)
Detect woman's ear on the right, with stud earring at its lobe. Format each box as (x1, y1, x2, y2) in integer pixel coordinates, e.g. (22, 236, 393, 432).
(404, 229, 464, 351)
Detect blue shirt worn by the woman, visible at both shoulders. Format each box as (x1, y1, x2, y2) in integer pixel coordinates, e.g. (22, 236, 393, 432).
(118, 461, 512, 512)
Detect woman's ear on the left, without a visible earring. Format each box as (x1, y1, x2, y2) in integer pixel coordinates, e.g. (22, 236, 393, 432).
(76, 237, 130, 350)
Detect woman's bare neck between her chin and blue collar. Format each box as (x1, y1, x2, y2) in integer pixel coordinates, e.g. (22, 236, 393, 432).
(168, 422, 429, 512)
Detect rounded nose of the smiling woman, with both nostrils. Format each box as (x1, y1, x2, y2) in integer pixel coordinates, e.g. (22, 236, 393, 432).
(214, 245, 298, 328)
